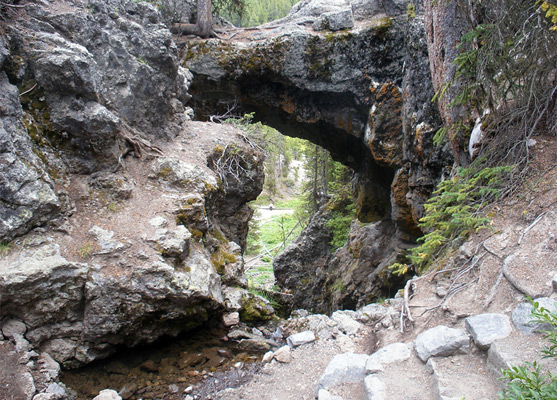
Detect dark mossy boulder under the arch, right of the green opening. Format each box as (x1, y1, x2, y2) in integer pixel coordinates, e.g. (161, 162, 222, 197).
(273, 211, 410, 313)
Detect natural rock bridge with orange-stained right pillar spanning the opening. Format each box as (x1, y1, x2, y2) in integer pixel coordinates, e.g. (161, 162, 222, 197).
(184, 5, 452, 236)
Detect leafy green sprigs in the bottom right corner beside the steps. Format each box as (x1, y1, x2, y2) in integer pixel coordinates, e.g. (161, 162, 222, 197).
(499, 299, 557, 400)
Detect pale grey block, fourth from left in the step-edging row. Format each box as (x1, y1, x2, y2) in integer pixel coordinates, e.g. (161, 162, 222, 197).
(464, 313, 512, 350)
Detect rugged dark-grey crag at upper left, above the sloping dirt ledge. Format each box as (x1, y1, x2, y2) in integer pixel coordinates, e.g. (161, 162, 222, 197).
(6, 0, 190, 173)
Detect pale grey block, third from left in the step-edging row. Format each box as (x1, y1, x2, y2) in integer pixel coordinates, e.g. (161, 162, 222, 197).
(415, 325, 470, 362)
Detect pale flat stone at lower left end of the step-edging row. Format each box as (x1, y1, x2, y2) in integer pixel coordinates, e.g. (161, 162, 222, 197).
(316, 353, 368, 395)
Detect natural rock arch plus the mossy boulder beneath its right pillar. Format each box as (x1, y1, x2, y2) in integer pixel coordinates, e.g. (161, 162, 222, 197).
(180, 0, 452, 311)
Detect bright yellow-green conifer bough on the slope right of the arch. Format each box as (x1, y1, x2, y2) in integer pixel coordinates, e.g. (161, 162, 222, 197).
(402, 160, 512, 273)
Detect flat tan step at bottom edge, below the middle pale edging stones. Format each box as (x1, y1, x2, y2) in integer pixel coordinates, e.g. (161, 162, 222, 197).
(427, 348, 500, 400)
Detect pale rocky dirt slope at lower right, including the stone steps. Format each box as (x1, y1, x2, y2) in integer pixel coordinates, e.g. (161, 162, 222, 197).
(185, 137, 557, 400)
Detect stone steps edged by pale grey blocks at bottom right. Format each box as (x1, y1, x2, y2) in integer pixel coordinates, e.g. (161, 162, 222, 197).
(316, 299, 557, 400)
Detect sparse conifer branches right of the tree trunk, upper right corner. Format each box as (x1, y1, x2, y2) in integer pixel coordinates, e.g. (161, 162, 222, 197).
(434, 0, 557, 162)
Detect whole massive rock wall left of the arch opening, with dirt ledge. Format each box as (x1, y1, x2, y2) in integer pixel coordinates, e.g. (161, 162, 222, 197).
(0, 0, 273, 378)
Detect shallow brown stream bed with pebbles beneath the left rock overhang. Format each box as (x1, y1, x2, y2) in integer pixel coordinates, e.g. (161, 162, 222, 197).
(61, 327, 261, 400)
